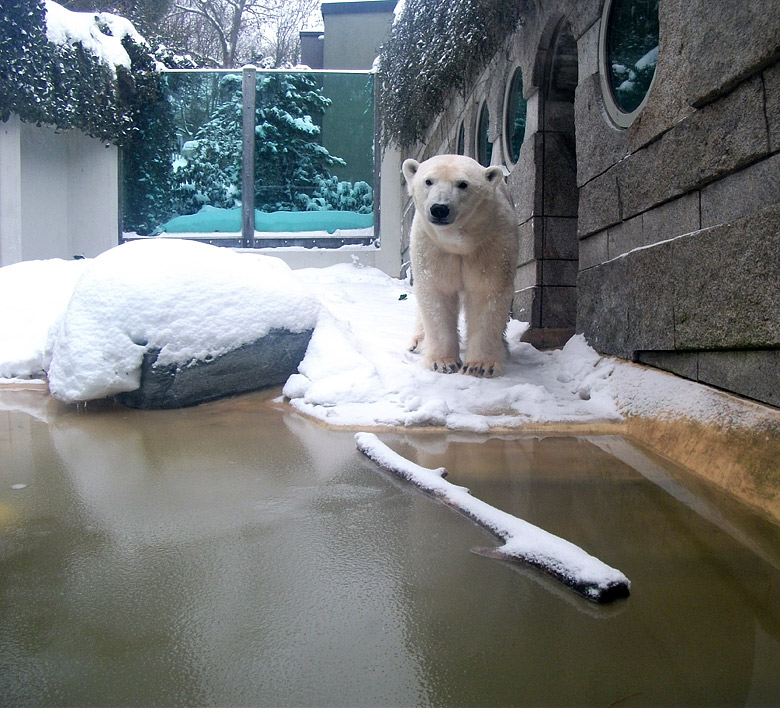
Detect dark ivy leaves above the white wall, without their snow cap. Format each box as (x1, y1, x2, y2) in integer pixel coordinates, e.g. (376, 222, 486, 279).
(0, 0, 161, 145)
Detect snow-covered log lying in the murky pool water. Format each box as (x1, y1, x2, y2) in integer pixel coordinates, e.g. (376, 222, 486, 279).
(355, 433, 631, 602)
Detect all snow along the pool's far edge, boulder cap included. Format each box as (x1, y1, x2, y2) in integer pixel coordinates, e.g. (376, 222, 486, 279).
(0, 239, 766, 432)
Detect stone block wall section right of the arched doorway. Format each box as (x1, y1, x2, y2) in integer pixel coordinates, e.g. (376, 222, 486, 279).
(577, 0, 780, 406)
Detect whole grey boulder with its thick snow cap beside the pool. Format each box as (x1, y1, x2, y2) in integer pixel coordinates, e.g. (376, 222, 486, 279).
(44, 240, 319, 408)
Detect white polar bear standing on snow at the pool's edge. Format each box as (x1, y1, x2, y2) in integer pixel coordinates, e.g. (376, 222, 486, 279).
(402, 155, 518, 376)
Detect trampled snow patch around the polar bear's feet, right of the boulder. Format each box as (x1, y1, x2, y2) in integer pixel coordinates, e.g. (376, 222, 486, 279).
(284, 265, 620, 432)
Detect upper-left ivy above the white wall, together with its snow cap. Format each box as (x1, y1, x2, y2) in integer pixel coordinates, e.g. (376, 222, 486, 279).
(0, 0, 159, 145)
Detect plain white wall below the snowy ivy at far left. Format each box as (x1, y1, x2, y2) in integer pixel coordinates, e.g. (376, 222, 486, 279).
(0, 116, 119, 266)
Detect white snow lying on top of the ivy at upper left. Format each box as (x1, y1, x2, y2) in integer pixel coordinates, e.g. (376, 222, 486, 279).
(44, 0, 147, 71)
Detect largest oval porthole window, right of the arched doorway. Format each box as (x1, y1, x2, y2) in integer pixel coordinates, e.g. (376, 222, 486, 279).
(599, 0, 659, 128)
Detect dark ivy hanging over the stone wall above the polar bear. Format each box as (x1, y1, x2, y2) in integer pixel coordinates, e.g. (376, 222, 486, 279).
(378, 0, 529, 148)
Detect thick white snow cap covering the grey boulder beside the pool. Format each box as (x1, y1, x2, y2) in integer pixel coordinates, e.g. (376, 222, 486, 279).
(48, 240, 319, 402)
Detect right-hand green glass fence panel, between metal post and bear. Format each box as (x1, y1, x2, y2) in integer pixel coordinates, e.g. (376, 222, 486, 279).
(250, 72, 374, 245)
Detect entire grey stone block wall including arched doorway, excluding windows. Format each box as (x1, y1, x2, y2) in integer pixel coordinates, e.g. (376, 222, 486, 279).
(394, 0, 780, 405)
